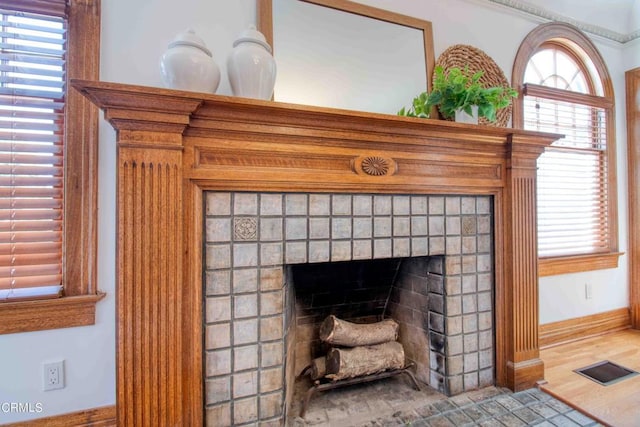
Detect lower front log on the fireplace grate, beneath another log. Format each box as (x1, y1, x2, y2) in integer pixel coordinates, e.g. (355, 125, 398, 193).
(326, 341, 404, 381)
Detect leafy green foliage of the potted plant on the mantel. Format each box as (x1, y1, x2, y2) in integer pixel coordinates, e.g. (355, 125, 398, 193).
(398, 67, 518, 121)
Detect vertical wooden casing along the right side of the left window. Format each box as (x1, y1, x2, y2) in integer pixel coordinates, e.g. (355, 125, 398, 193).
(63, 0, 101, 296)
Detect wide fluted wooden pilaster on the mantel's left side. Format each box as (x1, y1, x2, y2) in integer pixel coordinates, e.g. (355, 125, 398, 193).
(117, 151, 191, 425)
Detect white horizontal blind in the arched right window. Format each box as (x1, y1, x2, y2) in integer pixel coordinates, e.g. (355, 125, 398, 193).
(524, 90, 609, 257)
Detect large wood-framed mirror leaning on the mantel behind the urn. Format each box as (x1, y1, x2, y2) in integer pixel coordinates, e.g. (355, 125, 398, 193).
(257, 0, 435, 114)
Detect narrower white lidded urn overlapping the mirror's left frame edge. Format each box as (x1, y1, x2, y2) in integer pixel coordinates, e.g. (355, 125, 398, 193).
(227, 26, 276, 99)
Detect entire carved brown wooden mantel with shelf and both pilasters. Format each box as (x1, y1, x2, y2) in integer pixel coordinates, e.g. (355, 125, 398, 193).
(73, 81, 559, 426)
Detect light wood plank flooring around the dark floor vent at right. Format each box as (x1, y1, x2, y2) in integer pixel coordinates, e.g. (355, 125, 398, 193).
(540, 329, 640, 427)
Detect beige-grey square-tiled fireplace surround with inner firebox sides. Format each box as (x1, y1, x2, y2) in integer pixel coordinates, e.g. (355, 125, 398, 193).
(205, 192, 494, 425)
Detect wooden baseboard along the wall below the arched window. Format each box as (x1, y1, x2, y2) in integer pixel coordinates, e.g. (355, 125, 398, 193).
(538, 308, 631, 348)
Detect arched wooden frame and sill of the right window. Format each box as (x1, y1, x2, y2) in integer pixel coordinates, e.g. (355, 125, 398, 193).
(511, 22, 622, 276)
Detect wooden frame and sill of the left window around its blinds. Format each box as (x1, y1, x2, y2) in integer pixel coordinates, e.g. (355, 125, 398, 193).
(0, 0, 105, 334)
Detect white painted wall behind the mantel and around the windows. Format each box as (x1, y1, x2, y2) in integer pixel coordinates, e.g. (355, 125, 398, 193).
(0, 0, 640, 423)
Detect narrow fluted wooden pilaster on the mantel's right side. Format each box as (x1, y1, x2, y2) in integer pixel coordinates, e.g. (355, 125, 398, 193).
(496, 135, 544, 390)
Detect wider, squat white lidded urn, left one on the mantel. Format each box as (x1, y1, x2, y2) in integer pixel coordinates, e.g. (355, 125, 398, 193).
(160, 29, 220, 93)
